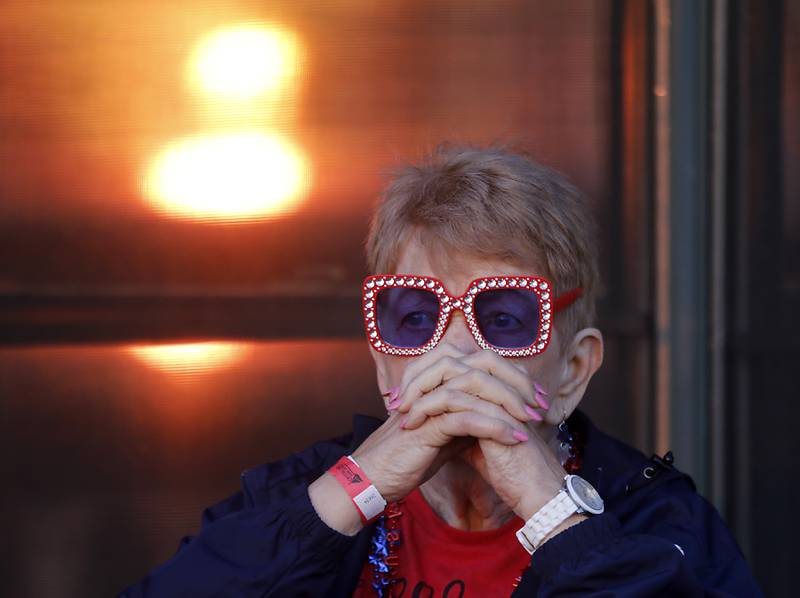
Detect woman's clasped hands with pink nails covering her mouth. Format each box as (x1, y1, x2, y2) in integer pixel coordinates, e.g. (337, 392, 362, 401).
(353, 343, 565, 520)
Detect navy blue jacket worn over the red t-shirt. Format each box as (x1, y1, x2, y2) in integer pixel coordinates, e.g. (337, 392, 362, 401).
(121, 412, 761, 598)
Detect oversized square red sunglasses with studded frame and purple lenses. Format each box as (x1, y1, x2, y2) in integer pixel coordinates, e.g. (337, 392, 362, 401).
(362, 274, 583, 357)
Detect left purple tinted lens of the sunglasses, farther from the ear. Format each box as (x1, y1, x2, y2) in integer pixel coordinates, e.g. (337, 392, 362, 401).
(376, 287, 439, 347)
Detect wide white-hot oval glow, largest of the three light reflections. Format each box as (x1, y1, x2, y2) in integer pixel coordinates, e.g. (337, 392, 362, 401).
(144, 132, 310, 220)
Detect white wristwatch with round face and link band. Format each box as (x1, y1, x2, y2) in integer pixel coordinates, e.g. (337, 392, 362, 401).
(517, 475, 603, 554)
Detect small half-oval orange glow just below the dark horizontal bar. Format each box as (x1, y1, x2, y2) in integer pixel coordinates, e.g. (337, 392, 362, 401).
(128, 341, 248, 374)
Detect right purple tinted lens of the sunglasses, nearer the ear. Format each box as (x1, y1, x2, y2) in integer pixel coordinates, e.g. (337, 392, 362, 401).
(474, 289, 539, 349)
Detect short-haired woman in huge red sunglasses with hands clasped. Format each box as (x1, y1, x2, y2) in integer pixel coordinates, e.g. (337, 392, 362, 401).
(120, 148, 760, 597)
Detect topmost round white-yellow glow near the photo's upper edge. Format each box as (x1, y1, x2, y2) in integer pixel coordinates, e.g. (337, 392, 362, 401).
(189, 24, 299, 100)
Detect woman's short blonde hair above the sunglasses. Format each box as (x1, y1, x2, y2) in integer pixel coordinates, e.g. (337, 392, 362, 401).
(365, 145, 599, 349)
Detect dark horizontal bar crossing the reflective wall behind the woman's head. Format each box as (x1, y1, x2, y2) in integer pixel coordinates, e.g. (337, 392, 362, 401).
(0, 288, 650, 346)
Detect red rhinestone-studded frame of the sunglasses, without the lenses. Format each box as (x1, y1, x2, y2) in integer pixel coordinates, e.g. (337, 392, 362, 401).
(361, 274, 581, 357)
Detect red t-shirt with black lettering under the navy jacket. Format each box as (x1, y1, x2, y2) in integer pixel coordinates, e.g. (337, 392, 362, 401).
(353, 489, 531, 598)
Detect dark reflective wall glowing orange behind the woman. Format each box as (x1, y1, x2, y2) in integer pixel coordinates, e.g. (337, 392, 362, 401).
(0, 0, 800, 596)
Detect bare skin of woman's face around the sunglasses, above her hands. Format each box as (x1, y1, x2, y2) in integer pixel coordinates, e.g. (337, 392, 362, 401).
(370, 236, 566, 432)
